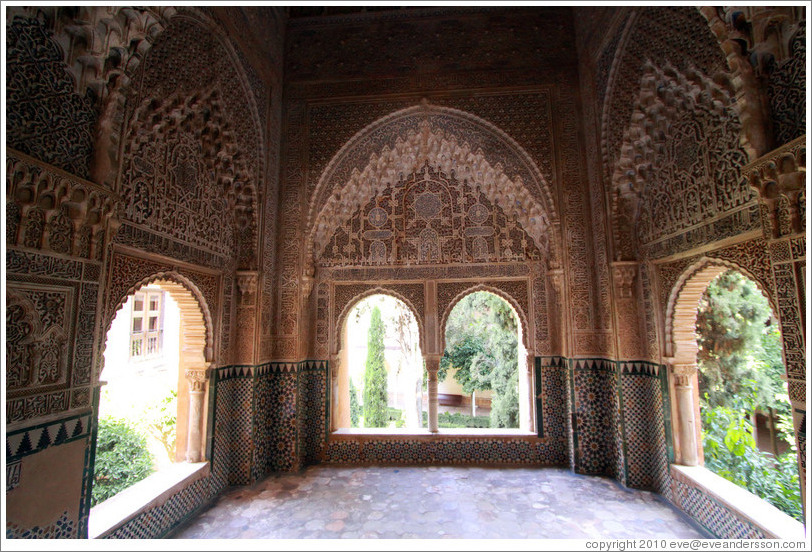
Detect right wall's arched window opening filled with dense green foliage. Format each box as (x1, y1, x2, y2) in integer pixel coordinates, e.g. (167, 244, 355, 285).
(696, 270, 803, 522)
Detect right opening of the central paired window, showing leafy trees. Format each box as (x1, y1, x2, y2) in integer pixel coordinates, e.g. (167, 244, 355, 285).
(437, 291, 529, 429)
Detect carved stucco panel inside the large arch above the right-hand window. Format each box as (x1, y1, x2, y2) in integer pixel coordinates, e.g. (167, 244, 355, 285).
(612, 62, 752, 260)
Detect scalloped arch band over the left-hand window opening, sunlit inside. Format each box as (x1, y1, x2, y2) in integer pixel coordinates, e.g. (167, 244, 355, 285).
(99, 271, 214, 368)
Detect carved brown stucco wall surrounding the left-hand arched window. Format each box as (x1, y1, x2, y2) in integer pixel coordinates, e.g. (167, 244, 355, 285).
(5, 8, 278, 537)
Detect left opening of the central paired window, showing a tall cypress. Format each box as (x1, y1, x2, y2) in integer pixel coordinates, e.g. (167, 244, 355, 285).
(337, 294, 428, 430)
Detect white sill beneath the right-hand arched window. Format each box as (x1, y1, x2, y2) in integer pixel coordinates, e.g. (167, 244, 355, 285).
(671, 464, 804, 540)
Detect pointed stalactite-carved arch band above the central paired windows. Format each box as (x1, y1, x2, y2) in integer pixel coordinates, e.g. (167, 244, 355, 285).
(306, 103, 558, 272)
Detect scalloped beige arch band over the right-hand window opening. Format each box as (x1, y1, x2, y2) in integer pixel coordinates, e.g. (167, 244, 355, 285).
(665, 257, 778, 364)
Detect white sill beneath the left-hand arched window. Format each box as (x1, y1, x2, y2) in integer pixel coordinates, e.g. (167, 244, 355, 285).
(88, 462, 210, 539)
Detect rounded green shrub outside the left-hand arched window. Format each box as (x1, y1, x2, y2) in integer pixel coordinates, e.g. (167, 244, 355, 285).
(91, 418, 154, 506)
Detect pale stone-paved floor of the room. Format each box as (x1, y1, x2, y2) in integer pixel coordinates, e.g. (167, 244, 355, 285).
(174, 466, 703, 539)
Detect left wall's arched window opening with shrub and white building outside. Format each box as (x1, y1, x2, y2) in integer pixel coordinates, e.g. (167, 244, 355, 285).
(91, 280, 208, 517)
